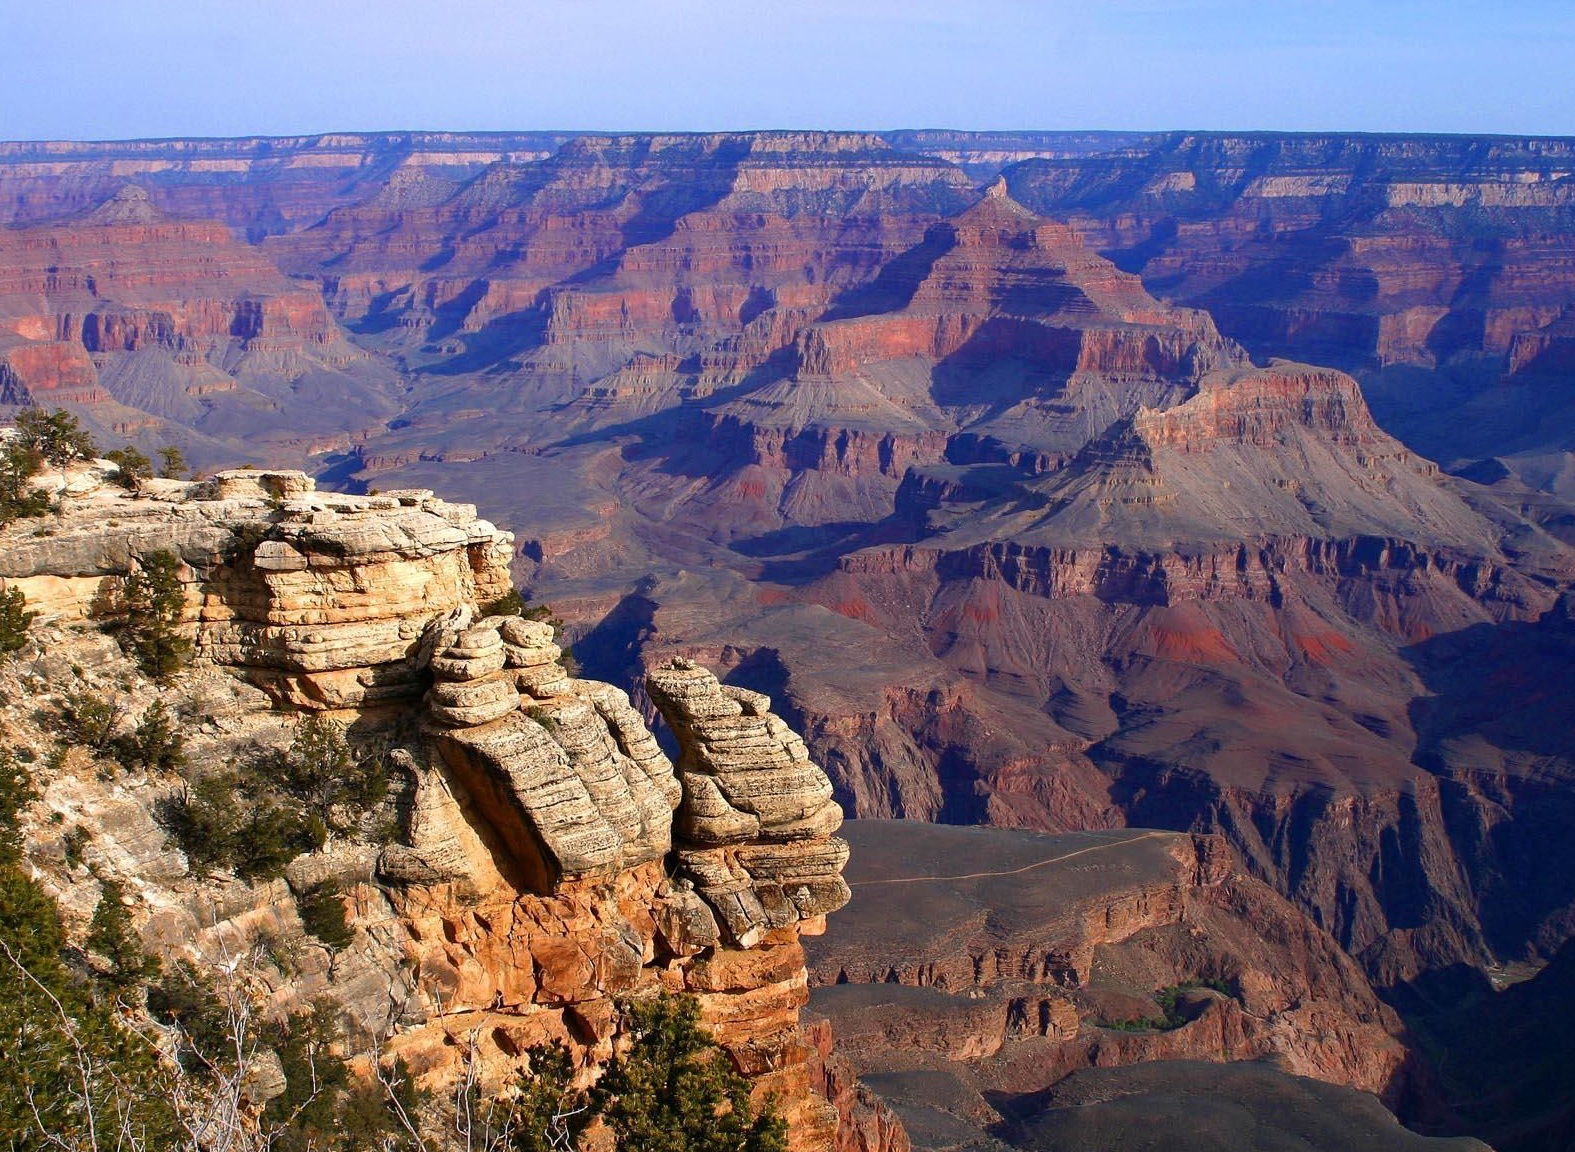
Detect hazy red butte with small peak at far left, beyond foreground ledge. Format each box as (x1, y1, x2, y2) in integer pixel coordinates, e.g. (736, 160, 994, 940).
(0, 184, 394, 463)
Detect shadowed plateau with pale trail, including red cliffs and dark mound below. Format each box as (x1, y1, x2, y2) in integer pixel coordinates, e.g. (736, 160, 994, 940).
(806, 821, 1482, 1150)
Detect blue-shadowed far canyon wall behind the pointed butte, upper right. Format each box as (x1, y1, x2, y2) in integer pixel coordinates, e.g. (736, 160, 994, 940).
(1005, 132, 1575, 487)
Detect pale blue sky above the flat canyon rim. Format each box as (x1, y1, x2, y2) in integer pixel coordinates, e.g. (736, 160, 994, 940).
(0, 0, 1575, 139)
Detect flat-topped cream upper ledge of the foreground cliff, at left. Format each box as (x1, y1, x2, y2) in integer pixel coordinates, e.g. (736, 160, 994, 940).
(0, 465, 512, 715)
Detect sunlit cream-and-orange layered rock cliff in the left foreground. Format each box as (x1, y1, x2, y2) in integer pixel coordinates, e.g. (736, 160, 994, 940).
(0, 465, 855, 1149)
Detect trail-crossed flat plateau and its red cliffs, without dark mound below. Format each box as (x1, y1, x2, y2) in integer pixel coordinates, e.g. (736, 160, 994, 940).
(810, 821, 1438, 1132)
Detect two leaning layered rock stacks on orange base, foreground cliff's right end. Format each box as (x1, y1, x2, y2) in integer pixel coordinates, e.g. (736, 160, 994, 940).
(400, 639, 847, 1146)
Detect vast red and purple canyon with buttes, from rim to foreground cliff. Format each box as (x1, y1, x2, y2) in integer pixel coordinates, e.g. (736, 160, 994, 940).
(9, 132, 1575, 1027)
